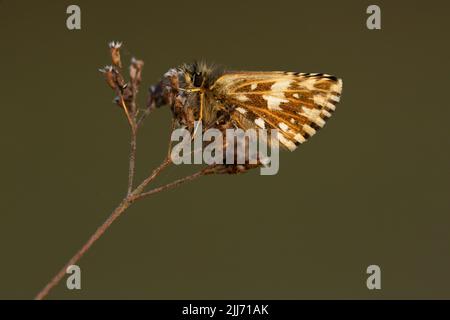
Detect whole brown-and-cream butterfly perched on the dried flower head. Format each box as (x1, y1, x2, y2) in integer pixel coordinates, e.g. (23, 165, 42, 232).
(148, 62, 342, 171)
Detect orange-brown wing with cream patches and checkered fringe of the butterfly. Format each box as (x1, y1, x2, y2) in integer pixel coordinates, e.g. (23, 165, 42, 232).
(211, 72, 342, 151)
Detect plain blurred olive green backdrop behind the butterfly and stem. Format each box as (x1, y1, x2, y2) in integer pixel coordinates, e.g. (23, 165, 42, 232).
(0, 0, 450, 299)
